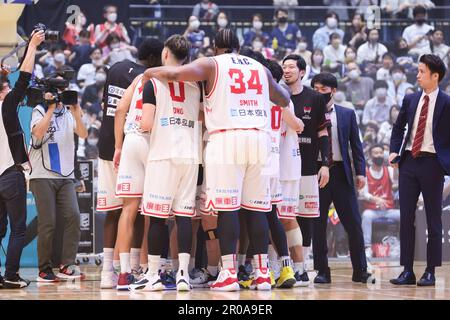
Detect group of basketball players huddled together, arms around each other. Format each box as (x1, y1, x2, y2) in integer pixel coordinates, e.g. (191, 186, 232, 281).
(97, 29, 370, 291)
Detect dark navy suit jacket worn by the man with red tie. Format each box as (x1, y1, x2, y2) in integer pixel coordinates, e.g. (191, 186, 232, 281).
(390, 90, 450, 175)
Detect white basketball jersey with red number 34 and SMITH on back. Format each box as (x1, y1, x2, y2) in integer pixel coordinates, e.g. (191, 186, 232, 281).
(204, 54, 270, 133)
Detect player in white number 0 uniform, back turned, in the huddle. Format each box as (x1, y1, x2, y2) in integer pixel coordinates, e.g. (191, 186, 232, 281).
(130, 35, 201, 291)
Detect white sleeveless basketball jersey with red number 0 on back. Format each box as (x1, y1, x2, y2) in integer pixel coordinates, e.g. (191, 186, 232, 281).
(148, 79, 202, 164)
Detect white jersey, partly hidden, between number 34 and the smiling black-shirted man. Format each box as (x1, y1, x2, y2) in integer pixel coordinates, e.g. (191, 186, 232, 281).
(280, 101, 302, 181)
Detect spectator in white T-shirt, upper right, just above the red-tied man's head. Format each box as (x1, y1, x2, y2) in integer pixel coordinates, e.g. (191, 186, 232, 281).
(402, 6, 433, 57)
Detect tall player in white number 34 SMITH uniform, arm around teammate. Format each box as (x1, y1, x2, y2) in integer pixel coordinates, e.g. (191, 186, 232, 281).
(145, 29, 289, 291)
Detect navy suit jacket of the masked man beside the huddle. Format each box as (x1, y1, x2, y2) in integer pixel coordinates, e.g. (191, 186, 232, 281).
(334, 105, 366, 186)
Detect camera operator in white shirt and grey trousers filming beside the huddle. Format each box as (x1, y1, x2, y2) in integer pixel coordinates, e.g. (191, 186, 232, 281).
(30, 80, 88, 282)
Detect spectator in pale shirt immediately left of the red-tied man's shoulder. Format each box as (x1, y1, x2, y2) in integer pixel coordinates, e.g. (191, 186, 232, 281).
(361, 80, 395, 125)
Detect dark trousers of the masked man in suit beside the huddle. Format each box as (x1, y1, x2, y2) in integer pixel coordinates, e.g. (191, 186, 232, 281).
(313, 162, 367, 272)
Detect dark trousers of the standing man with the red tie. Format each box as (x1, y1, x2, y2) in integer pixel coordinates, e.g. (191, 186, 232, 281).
(399, 151, 445, 268)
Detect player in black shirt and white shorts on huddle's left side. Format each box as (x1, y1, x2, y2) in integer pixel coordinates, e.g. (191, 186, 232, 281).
(97, 39, 163, 289)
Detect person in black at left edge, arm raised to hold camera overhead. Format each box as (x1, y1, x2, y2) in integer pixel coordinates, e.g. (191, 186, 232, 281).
(0, 31, 45, 289)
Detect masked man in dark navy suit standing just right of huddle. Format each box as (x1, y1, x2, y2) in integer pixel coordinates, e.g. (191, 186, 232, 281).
(311, 73, 375, 283)
